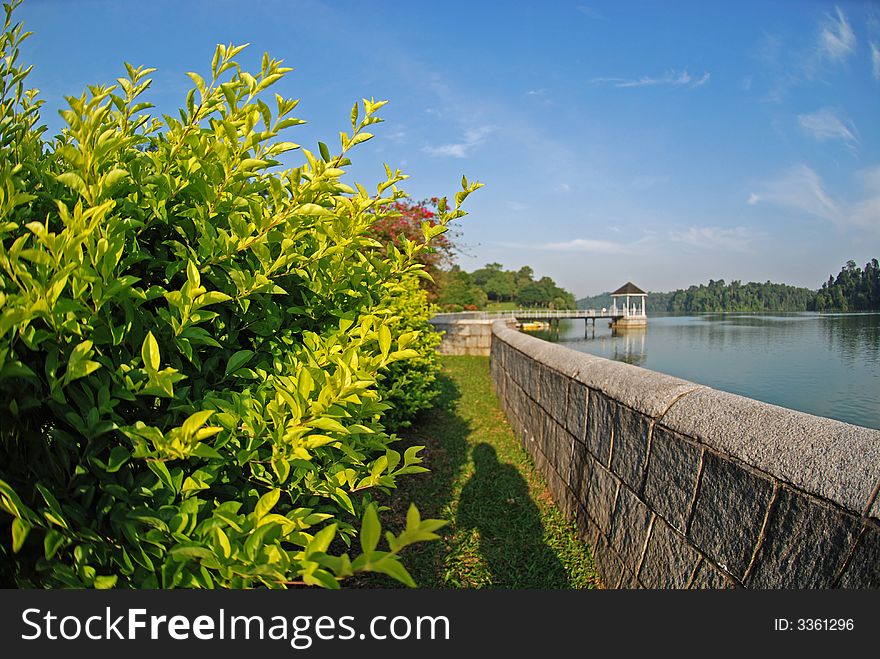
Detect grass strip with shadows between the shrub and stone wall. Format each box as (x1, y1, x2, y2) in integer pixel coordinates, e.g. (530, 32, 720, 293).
(356, 357, 599, 589)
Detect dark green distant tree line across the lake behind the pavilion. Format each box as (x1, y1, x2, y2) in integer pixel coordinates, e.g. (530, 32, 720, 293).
(577, 259, 880, 313)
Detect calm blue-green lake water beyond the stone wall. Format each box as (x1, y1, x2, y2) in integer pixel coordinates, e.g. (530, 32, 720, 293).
(531, 313, 880, 429)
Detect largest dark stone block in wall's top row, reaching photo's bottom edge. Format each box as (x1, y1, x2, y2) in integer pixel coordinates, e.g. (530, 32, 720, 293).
(744, 488, 861, 588)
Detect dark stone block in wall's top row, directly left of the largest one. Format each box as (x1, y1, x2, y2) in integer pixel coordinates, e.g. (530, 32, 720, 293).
(688, 451, 773, 579)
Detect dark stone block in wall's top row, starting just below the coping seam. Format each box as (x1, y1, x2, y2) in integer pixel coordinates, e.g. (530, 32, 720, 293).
(644, 426, 702, 532)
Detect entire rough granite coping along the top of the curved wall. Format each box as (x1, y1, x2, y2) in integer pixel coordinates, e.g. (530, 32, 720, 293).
(492, 321, 880, 518)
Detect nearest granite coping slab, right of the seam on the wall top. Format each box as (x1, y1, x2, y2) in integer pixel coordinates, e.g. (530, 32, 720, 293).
(662, 388, 880, 515)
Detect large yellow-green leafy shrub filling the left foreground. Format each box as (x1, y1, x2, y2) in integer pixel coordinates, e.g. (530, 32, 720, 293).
(0, 3, 479, 588)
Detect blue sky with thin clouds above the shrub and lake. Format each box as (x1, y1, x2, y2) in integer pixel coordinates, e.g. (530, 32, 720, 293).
(18, 0, 880, 296)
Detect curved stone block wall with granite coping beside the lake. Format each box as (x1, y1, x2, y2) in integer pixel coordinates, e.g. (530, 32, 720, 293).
(490, 322, 880, 588)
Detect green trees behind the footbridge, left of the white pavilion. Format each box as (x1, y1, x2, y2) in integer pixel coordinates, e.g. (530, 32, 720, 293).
(437, 263, 576, 310)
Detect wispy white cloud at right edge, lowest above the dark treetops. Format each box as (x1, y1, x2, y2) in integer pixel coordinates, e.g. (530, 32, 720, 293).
(748, 164, 880, 230)
